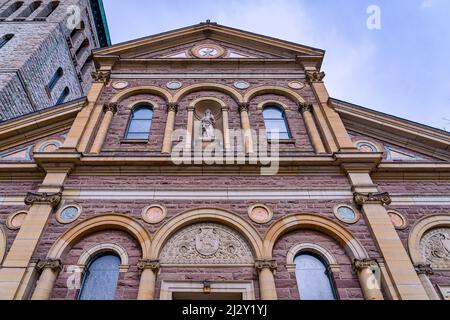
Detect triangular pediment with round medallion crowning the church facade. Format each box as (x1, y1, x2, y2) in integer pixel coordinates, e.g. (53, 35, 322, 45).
(94, 22, 324, 64)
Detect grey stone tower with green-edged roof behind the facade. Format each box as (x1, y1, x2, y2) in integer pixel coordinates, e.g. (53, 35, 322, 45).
(0, 0, 110, 121)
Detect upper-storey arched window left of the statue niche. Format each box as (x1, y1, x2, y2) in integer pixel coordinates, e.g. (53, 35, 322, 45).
(126, 106, 153, 140)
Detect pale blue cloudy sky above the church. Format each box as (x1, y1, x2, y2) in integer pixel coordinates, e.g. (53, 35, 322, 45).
(103, 0, 450, 131)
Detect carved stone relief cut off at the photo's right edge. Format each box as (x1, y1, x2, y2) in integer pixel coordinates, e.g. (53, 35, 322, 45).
(420, 228, 450, 269)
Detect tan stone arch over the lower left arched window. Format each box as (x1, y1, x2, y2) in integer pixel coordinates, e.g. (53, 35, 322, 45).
(47, 214, 152, 259)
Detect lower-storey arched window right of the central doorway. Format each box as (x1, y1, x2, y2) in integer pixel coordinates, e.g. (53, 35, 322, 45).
(294, 253, 336, 300)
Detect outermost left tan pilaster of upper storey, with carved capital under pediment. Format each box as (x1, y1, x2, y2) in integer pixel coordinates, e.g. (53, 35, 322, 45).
(60, 70, 111, 152)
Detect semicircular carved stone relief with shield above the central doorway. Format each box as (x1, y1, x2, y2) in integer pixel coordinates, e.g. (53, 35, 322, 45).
(160, 223, 254, 265)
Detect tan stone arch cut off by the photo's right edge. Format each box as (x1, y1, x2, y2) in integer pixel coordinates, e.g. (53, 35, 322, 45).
(408, 214, 450, 265)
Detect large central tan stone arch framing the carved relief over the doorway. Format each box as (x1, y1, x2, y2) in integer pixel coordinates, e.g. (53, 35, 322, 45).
(151, 208, 262, 259)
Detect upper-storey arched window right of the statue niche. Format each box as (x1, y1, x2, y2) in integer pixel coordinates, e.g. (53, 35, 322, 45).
(263, 106, 291, 140)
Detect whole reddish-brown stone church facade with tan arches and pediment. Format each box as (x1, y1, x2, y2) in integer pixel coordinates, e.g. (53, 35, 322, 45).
(0, 21, 450, 300)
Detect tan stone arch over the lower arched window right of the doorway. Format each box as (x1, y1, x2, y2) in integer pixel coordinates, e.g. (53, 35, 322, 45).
(264, 214, 368, 260)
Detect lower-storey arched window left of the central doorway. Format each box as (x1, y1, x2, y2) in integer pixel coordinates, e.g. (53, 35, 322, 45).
(78, 253, 120, 300)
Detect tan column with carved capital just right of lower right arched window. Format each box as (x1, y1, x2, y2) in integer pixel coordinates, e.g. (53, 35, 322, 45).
(353, 259, 384, 300)
